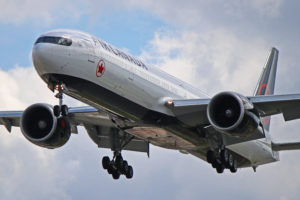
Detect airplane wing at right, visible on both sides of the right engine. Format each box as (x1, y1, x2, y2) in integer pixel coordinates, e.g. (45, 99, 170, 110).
(172, 94, 300, 126)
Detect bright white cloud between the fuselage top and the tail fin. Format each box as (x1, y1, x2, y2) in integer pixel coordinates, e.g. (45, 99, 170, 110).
(142, 29, 269, 95)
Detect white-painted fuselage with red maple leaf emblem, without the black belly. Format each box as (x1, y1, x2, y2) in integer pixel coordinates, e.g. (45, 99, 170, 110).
(32, 30, 277, 166)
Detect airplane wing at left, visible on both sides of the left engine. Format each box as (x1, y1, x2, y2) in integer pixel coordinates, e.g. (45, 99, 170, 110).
(0, 106, 149, 154)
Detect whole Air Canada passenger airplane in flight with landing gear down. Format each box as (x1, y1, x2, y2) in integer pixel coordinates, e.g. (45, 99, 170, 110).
(0, 29, 300, 179)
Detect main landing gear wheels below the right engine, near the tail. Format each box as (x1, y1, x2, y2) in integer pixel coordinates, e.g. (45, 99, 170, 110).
(206, 149, 237, 174)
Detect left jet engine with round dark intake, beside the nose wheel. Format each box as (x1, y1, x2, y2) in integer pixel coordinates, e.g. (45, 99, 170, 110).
(20, 103, 71, 149)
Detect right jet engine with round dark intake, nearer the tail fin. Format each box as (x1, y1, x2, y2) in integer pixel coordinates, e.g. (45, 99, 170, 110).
(207, 92, 260, 137)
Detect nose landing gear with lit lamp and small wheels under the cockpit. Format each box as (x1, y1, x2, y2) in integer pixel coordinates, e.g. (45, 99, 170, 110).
(53, 84, 69, 117)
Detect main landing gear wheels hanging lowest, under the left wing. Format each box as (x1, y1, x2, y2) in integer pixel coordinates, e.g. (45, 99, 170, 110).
(102, 152, 133, 179)
